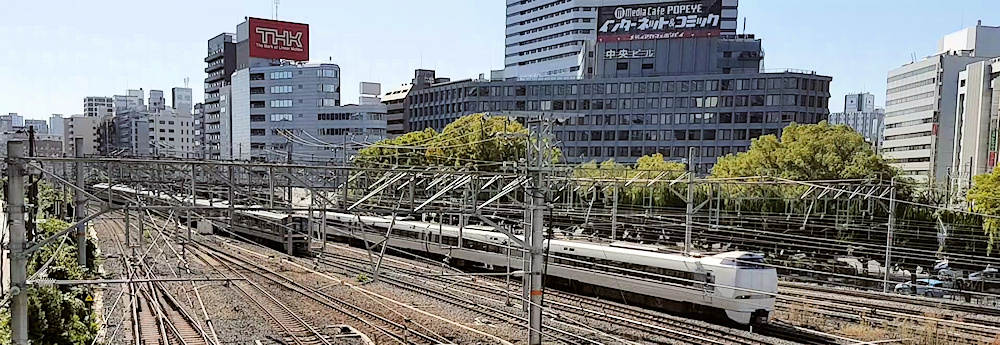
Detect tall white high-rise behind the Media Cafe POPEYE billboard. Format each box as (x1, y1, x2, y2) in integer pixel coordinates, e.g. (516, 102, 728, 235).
(504, 0, 739, 78)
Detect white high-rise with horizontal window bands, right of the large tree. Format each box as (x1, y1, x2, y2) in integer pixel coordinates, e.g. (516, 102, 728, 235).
(882, 25, 1000, 183)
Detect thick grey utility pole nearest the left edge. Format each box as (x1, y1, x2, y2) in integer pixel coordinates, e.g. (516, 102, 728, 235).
(7, 140, 28, 345)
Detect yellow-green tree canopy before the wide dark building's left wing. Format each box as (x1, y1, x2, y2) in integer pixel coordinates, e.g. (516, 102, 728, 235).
(356, 114, 560, 170)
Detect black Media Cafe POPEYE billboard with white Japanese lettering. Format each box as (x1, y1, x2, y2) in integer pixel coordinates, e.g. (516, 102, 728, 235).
(597, 0, 722, 42)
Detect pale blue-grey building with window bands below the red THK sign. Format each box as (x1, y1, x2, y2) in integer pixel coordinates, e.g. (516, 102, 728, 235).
(228, 64, 386, 163)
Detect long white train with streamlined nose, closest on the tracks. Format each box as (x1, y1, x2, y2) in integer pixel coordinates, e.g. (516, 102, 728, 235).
(308, 208, 778, 324)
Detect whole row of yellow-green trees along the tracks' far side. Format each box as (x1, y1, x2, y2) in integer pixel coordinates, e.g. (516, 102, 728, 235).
(366, 114, 1000, 255)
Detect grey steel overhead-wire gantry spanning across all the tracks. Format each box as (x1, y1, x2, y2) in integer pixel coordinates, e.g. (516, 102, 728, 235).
(5, 136, 956, 344)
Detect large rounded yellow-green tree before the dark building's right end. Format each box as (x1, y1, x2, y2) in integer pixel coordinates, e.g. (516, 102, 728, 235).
(712, 121, 897, 181)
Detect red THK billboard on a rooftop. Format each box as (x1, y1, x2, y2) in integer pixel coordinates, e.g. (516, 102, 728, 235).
(247, 18, 309, 61)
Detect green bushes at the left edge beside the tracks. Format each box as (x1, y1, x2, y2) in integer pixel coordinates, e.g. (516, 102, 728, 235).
(0, 182, 99, 345)
